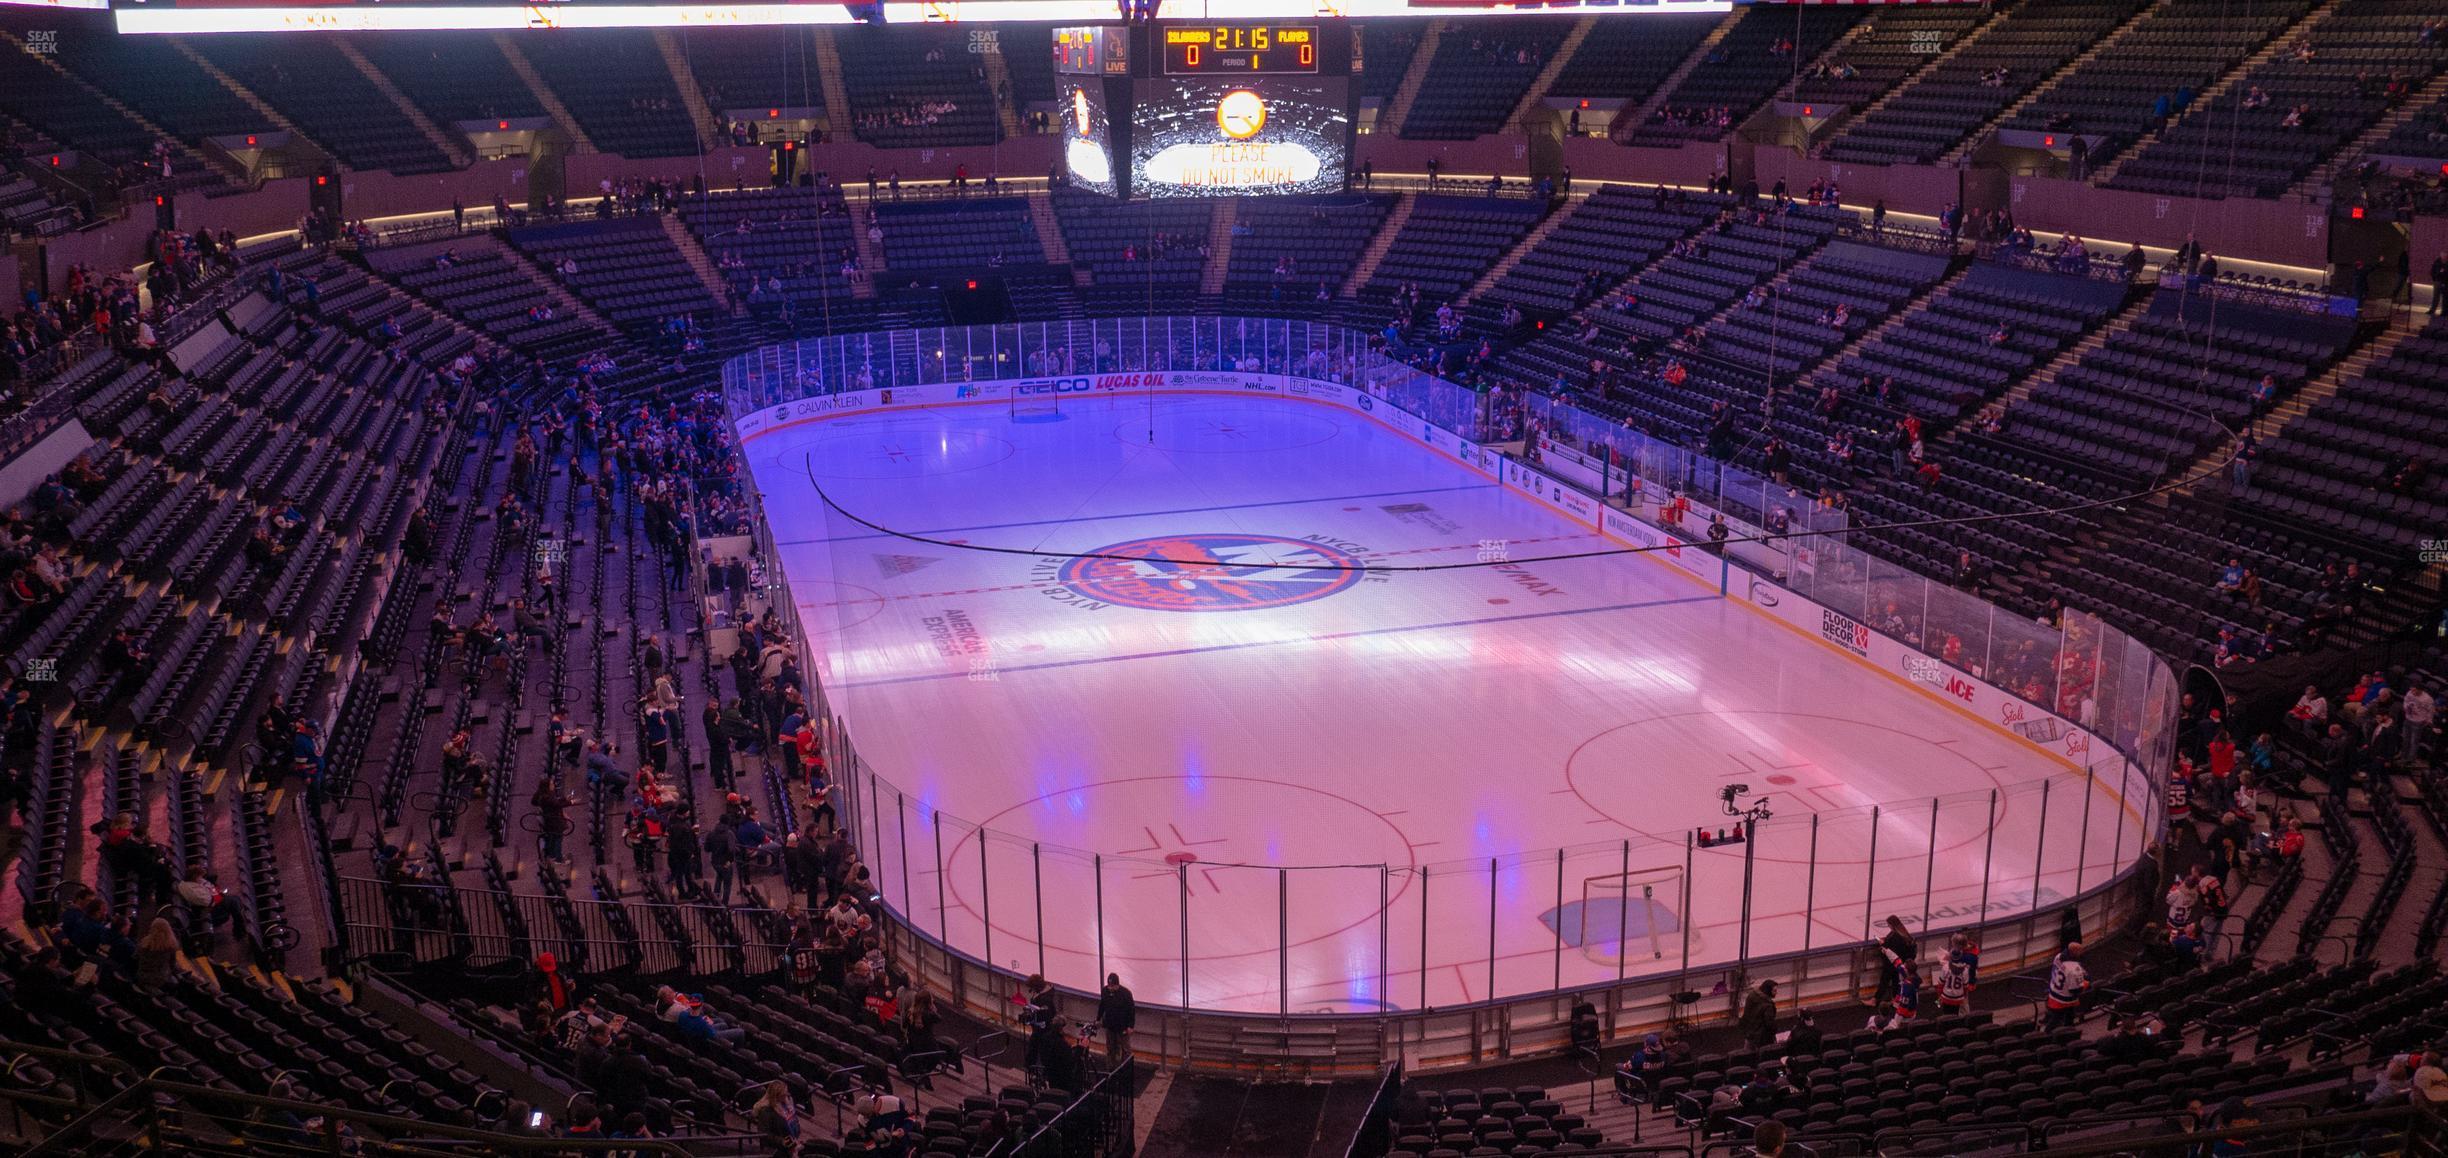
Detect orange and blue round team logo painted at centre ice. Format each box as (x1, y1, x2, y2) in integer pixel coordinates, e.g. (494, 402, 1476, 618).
(1058, 531, 1364, 612)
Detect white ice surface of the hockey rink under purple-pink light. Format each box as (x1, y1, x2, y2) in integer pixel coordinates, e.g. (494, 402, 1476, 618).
(744, 394, 2140, 1014)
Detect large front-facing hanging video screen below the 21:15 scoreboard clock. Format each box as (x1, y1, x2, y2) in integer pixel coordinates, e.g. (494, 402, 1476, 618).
(1131, 73, 1351, 198)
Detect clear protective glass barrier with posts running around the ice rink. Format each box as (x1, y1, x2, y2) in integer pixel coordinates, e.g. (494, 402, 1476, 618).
(695, 318, 2174, 1072)
